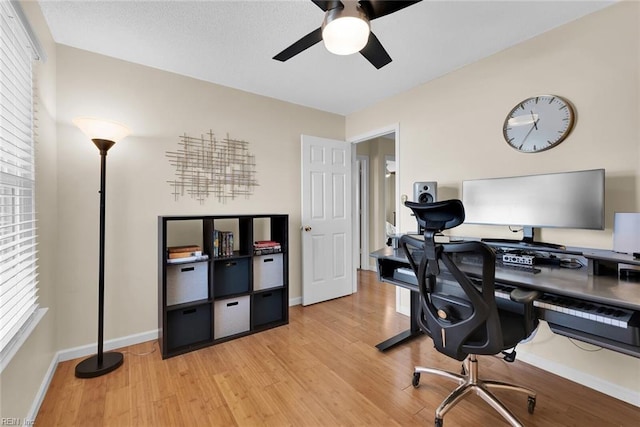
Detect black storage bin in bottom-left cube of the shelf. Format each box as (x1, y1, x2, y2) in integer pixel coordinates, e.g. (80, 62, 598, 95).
(166, 304, 212, 349)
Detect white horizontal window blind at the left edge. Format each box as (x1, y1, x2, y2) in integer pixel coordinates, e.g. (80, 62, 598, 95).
(0, 1, 38, 354)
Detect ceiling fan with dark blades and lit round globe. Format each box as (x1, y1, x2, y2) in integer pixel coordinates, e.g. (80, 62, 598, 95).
(273, 0, 421, 69)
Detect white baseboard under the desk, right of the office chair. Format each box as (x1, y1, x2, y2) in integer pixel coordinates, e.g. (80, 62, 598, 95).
(518, 352, 640, 407)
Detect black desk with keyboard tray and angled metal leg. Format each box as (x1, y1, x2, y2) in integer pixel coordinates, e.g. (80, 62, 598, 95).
(370, 247, 640, 358)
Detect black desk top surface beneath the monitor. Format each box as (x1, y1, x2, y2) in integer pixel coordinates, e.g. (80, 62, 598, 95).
(370, 247, 640, 310)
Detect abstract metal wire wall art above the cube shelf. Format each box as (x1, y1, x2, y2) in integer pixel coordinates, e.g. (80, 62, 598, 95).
(166, 131, 258, 203)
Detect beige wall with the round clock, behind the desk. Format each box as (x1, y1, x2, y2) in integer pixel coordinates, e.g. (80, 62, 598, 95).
(347, 2, 640, 404)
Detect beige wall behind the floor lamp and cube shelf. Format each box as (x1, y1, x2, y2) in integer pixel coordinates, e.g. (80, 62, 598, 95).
(56, 46, 345, 349)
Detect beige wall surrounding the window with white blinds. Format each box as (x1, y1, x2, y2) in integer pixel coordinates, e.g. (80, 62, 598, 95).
(0, 2, 58, 420)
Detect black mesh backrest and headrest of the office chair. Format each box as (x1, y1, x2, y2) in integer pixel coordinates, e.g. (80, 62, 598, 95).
(400, 200, 504, 360)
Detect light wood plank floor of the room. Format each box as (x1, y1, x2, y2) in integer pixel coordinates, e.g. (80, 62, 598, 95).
(36, 272, 640, 427)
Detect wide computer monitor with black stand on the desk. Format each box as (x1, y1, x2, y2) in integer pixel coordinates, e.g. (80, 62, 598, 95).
(462, 169, 604, 247)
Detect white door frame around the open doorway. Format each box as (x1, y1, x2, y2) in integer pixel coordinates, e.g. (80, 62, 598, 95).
(346, 123, 401, 292)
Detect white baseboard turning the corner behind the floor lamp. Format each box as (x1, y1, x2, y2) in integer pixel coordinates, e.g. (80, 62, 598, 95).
(27, 329, 159, 420)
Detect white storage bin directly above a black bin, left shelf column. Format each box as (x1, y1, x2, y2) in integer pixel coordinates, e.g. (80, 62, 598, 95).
(167, 262, 209, 305)
